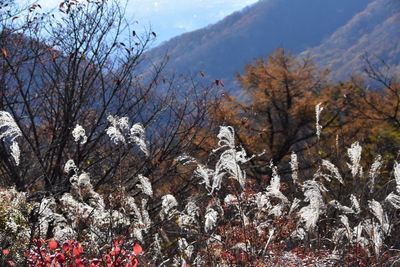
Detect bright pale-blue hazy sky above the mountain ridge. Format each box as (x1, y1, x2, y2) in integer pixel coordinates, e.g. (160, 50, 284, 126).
(16, 0, 258, 43)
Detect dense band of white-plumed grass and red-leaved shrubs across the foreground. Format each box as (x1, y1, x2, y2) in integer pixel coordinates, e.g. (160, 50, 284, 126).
(1, 110, 400, 266)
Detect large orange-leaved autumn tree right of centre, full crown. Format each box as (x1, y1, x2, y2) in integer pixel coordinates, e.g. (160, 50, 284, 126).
(209, 49, 362, 187)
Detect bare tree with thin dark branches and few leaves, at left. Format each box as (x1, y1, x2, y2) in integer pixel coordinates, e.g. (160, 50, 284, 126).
(0, 0, 217, 197)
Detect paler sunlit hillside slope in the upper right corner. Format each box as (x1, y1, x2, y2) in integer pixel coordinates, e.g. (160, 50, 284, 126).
(304, 0, 400, 80)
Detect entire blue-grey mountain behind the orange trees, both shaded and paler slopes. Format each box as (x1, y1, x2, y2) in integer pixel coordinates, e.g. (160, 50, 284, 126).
(147, 0, 400, 93)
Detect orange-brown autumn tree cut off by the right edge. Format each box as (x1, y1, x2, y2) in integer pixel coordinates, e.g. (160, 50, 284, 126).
(340, 56, 400, 161)
